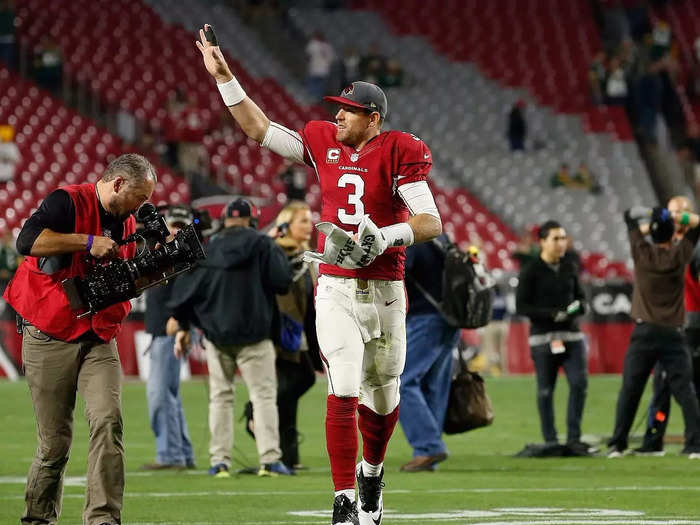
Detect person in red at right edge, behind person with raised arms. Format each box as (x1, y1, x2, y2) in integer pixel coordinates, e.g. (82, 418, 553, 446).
(634, 196, 700, 455)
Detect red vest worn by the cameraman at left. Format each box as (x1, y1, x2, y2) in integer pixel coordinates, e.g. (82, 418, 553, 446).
(3, 184, 136, 341)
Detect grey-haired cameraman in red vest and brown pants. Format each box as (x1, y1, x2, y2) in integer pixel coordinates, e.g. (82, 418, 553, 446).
(4, 154, 156, 525)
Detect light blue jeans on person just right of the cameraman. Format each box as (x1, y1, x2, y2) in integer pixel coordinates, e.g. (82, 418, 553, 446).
(146, 336, 194, 465)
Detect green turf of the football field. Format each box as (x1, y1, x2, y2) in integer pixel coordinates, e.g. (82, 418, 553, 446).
(0, 376, 700, 525)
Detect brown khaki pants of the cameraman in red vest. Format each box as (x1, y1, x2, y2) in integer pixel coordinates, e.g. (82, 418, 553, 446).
(22, 326, 124, 525)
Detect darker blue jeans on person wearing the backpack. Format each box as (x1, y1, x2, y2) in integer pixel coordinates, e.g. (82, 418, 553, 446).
(399, 313, 459, 457)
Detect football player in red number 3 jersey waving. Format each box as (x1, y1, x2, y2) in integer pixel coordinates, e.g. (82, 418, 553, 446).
(197, 25, 442, 525)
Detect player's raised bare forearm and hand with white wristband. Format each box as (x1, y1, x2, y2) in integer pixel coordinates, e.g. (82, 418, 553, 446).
(196, 24, 270, 143)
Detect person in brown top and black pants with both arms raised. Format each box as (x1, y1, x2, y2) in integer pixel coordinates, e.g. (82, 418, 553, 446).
(608, 207, 700, 458)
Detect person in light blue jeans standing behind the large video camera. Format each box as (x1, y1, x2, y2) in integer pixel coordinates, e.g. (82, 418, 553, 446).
(141, 206, 194, 470)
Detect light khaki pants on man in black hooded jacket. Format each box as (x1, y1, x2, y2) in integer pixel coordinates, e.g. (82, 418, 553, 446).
(204, 339, 282, 468)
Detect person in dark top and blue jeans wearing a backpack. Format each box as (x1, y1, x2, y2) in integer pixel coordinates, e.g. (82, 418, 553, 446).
(399, 234, 459, 472)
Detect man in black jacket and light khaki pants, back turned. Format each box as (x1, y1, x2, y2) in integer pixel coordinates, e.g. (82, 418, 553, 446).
(168, 199, 293, 477)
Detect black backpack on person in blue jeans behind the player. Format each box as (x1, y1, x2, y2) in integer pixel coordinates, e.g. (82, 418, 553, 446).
(410, 239, 496, 328)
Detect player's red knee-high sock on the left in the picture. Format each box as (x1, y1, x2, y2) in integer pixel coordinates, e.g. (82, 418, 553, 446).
(326, 394, 358, 491)
